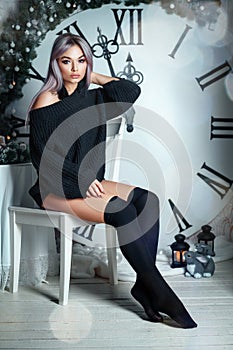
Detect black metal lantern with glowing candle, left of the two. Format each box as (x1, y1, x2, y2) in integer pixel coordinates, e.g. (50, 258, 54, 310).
(170, 233, 190, 268)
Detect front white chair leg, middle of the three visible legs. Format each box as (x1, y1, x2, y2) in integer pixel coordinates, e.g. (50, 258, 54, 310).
(59, 215, 72, 305)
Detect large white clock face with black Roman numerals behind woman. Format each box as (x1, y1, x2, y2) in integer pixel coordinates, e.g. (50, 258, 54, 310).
(18, 2, 233, 247)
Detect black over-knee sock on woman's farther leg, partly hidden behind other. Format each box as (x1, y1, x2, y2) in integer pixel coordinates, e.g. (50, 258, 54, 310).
(127, 187, 163, 322)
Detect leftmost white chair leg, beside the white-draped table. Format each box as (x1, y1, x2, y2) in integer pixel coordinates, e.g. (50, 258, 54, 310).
(10, 212, 22, 293)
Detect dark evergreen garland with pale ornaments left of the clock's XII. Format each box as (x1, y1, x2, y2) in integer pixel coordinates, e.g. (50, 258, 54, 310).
(0, 0, 120, 114)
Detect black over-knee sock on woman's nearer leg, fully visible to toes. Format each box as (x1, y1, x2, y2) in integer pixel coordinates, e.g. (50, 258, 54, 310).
(104, 197, 197, 328)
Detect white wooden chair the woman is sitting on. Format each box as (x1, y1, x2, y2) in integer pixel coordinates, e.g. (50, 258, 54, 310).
(9, 118, 124, 305)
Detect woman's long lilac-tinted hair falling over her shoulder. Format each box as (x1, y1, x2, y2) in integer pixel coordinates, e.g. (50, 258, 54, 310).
(29, 33, 93, 111)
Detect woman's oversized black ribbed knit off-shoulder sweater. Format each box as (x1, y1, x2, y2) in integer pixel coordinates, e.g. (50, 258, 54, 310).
(29, 79, 140, 206)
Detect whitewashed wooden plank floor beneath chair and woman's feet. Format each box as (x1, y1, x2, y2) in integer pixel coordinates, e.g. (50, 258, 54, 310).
(0, 260, 233, 350)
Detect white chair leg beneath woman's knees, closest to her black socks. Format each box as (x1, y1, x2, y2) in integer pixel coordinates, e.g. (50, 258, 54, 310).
(105, 225, 118, 285)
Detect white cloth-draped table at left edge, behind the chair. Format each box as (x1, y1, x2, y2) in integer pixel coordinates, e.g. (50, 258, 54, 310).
(0, 163, 48, 290)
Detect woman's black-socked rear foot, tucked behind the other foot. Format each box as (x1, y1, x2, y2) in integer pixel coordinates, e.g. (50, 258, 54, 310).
(131, 282, 163, 322)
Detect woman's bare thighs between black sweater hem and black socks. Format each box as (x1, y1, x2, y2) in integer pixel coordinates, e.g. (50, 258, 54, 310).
(43, 180, 135, 223)
